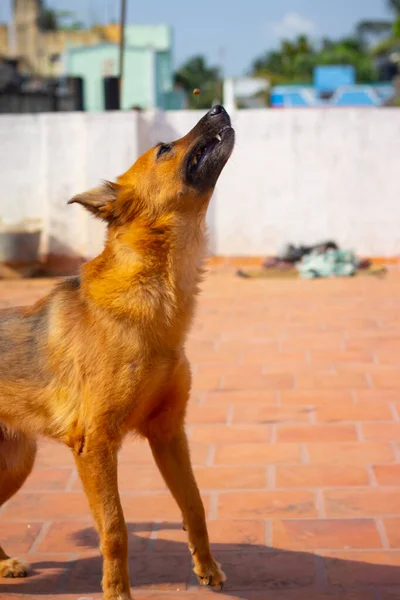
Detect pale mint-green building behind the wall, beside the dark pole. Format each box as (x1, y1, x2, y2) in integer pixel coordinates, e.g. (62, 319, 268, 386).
(65, 25, 186, 111)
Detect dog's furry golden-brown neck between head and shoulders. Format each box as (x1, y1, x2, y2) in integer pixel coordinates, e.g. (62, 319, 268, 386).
(82, 214, 206, 336)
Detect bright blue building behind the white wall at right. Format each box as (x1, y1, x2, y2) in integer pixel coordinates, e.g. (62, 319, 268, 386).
(271, 65, 394, 108)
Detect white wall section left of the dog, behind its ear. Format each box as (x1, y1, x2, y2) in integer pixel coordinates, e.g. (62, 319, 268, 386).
(0, 111, 138, 256)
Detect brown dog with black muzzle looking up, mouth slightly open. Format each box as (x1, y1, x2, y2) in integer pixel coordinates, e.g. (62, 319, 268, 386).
(0, 106, 234, 600)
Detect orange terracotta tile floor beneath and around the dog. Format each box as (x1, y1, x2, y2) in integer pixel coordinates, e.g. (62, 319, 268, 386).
(0, 269, 400, 600)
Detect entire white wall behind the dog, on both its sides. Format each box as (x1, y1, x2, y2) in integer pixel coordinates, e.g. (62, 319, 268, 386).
(0, 108, 400, 256)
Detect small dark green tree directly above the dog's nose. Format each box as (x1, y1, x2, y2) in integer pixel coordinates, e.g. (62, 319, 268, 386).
(175, 56, 221, 108)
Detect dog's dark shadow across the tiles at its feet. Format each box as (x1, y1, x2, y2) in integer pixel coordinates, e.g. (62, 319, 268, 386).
(0, 523, 400, 600)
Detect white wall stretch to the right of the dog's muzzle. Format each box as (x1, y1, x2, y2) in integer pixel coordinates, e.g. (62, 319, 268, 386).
(215, 108, 400, 256)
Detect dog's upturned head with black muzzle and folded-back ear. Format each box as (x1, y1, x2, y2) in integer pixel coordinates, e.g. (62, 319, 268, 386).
(69, 105, 235, 224)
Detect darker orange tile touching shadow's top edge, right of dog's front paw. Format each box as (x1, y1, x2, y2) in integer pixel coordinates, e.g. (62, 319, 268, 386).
(272, 519, 382, 551)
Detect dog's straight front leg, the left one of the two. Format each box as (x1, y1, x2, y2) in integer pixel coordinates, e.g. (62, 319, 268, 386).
(74, 432, 131, 600)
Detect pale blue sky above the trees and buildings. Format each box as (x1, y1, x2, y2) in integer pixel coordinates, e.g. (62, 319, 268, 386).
(0, 0, 389, 76)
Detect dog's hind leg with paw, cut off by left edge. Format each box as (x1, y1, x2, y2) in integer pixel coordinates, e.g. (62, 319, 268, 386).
(0, 425, 36, 577)
